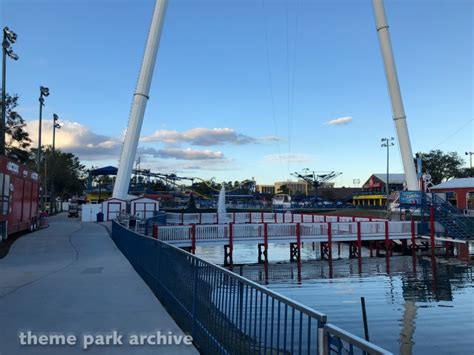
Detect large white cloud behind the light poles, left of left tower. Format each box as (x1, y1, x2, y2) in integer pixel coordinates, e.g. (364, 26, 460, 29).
(26, 120, 122, 160)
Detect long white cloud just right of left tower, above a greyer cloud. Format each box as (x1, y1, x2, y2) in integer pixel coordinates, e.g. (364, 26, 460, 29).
(140, 127, 258, 146)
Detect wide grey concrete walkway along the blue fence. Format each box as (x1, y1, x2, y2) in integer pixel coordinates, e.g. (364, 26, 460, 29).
(0, 216, 198, 355)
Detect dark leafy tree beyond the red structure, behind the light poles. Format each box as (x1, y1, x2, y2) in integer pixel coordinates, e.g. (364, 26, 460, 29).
(39, 146, 86, 199)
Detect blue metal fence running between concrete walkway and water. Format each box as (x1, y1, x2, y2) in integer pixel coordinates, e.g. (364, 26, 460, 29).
(112, 221, 389, 354)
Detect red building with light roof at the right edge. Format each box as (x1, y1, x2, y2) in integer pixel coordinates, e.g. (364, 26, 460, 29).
(430, 178, 474, 213)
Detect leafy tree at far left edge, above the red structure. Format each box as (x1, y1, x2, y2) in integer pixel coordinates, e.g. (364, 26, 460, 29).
(1, 94, 34, 164)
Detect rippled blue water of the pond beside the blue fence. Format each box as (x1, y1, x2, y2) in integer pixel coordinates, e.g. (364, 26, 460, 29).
(193, 245, 474, 354)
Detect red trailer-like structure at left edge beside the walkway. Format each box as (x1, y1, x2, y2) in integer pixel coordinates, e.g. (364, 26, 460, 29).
(0, 156, 39, 242)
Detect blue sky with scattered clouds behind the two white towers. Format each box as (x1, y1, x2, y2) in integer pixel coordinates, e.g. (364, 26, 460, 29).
(0, 0, 474, 186)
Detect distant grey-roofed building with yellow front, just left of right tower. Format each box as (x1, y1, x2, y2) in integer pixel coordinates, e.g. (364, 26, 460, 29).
(352, 174, 405, 206)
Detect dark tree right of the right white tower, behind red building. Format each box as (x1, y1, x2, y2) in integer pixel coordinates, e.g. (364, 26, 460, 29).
(422, 150, 464, 185)
